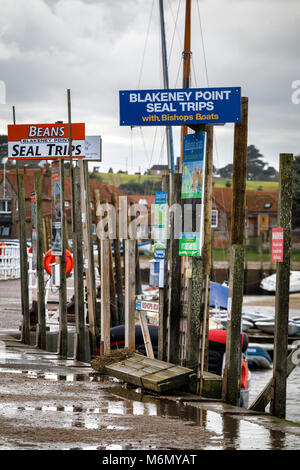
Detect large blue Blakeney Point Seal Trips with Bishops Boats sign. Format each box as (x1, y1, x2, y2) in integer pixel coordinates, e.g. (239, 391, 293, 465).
(119, 87, 241, 126)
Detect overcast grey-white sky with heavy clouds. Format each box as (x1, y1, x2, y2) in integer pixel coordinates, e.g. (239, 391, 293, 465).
(0, 0, 300, 172)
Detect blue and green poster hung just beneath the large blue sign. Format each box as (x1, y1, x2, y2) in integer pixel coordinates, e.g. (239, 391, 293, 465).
(181, 132, 205, 199)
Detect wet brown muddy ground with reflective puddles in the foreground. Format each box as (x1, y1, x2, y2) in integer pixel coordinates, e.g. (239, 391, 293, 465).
(0, 333, 300, 450)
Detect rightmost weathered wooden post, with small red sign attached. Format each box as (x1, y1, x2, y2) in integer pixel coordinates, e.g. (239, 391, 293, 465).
(271, 153, 293, 418)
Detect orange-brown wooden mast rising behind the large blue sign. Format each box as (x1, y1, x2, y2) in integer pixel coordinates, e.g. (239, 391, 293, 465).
(180, 0, 192, 171)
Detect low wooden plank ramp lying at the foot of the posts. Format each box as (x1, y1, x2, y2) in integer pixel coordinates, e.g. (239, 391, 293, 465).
(105, 353, 197, 392)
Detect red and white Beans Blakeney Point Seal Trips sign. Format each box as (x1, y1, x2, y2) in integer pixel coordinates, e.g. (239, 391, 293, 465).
(8, 123, 85, 160)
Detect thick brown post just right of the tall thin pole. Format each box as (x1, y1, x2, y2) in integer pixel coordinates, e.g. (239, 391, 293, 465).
(72, 168, 85, 361)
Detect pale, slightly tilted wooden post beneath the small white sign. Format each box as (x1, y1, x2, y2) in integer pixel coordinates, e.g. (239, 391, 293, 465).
(79, 160, 96, 356)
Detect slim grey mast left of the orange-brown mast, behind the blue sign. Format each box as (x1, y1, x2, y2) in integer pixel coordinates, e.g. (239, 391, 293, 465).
(159, 0, 174, 173)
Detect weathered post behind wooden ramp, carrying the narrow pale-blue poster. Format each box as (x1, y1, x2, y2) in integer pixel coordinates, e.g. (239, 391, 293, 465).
(158, 175, 170, 361)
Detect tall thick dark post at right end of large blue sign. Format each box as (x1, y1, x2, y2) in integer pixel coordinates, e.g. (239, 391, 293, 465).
(223, 98, 248, 406)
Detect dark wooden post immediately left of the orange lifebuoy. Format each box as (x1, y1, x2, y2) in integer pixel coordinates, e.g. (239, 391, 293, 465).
(34, 172, 46, 349)
